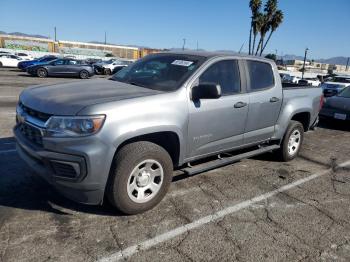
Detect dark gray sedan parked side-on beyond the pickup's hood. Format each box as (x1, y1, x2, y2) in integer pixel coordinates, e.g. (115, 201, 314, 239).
(27, 58, 94, 79)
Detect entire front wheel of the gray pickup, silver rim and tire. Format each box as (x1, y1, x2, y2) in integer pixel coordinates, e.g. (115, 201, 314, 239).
(107, 141, 173, 214)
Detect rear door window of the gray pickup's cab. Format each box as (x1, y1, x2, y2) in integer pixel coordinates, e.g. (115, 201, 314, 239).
(247, 60, 275, 92)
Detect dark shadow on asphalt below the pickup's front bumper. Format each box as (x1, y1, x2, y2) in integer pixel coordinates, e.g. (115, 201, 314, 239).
(0, 137, 123, 216)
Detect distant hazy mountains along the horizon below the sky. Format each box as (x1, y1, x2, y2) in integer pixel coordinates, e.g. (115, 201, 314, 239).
(0, 31, 348, 65)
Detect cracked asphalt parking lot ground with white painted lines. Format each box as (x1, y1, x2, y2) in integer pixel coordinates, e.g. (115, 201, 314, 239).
(0, 68, 350, 261)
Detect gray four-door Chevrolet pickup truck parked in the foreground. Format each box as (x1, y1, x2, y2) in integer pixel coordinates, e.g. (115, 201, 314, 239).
(14, 52, 323, 214)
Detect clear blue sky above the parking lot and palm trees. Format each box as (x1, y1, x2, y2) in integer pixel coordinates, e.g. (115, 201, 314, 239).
(0, 0, 350, 58)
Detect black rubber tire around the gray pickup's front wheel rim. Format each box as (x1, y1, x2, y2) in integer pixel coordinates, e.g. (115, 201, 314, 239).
(106, 141, 173, 215)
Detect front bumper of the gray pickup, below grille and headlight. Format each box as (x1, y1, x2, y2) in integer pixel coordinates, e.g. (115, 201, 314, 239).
(13, 127, 114, 205)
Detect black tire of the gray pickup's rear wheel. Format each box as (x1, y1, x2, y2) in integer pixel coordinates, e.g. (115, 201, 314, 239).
(276, 120, 304, 162)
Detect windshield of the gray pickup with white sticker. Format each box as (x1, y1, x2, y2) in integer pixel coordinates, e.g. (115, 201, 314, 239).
(111, 54, 205, 91)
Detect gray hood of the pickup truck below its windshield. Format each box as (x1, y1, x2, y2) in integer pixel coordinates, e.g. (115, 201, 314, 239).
(20, 79, 162, 115)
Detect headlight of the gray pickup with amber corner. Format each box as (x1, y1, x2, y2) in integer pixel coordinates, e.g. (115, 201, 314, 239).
(45, 115, 106, 137)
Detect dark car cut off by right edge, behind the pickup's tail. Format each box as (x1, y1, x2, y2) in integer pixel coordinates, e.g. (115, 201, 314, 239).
(320, 86, 350, 120)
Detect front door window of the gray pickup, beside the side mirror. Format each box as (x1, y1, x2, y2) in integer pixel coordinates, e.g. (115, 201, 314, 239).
(199, 60, 241, 95)
